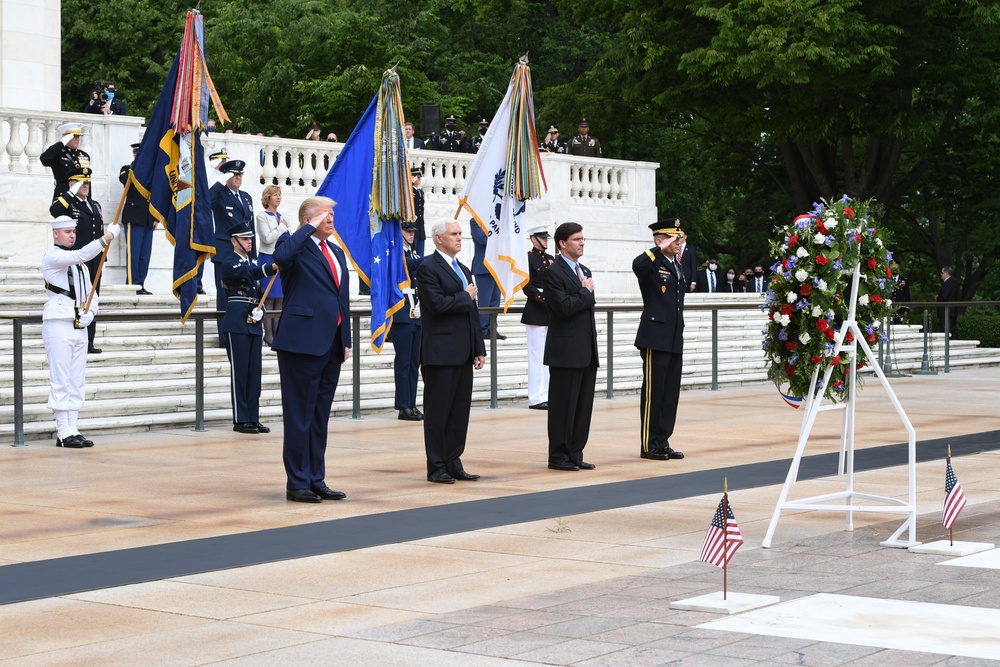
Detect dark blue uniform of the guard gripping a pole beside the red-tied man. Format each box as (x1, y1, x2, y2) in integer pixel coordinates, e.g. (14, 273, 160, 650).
(216, 245, 274, 424)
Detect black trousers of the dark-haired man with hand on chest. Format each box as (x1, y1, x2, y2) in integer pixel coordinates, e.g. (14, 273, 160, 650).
(548, 364, 597, 464)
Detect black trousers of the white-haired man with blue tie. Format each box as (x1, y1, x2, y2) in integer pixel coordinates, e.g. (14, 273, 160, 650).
(421, 359, 472, 475)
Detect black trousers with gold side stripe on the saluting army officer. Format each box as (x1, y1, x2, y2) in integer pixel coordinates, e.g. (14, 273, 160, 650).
(639, 348, 683, 453)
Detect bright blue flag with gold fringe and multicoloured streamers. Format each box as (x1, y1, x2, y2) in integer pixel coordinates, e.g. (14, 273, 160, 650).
(316, 69, 414, 352)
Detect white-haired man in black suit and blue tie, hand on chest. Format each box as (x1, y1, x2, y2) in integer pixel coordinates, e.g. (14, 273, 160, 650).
(417, 220, 486, 484)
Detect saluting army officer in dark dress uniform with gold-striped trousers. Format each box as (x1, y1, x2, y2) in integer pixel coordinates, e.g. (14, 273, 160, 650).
(632, 218, 687, 461)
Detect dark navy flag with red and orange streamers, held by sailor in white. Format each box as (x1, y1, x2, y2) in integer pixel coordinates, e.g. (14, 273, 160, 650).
(125, 10, 229, 322)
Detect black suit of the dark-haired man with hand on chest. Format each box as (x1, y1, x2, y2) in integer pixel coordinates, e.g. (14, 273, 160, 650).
(542, 257, 600, 465)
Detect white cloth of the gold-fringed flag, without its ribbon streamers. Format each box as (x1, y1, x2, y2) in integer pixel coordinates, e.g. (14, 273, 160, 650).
(459, 77, 534, 311)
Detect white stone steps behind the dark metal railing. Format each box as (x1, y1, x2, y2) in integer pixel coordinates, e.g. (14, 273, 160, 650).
(0, 256, 1000, 444)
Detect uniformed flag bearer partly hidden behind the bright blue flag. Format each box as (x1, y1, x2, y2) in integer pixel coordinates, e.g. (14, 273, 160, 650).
(392, 222, 424, 422)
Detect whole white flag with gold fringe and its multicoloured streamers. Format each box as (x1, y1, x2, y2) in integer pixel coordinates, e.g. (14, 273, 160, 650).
(459, 56, 546, 311)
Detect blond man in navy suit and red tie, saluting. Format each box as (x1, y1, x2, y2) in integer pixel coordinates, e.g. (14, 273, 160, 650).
(271, 197, 351, 503)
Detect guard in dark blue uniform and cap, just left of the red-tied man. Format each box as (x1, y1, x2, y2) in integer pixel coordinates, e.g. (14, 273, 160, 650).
(215, 222, 277, 433)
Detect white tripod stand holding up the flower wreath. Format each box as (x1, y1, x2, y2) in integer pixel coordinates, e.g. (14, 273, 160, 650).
(761, 262, 920, 549)
